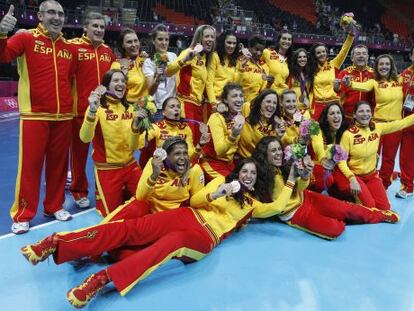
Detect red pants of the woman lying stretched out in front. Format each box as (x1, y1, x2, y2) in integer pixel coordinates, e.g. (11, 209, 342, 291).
(53, 208, 214, 295)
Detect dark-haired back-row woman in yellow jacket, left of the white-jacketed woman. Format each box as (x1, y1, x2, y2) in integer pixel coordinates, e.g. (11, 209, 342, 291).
(111, 28, 148, 103)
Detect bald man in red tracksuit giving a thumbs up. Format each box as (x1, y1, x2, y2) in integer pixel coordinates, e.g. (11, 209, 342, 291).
(0, 0, 76, 234)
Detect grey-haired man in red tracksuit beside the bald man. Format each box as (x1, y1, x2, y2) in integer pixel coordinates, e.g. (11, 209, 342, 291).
(70, 12, 115, 208)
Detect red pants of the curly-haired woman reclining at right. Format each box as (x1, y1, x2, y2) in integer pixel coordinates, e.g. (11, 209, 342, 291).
(287, 190, 392, 239)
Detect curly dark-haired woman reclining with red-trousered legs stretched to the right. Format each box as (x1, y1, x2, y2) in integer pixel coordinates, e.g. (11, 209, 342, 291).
(253, 136, 399, 240)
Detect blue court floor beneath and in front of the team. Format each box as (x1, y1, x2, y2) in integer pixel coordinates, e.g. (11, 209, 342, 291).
(0, 120, 414, 311)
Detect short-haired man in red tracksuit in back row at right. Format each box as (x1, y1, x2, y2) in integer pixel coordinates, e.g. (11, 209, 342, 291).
(335, 44, 374, 121)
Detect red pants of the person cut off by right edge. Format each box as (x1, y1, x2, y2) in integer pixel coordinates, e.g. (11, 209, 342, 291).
(400, 125, 414, 192)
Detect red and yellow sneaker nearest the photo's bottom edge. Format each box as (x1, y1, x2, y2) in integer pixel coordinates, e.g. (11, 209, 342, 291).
(66, 270, 109, 309)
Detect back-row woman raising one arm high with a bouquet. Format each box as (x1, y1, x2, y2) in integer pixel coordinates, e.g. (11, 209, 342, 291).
(308, 33, 354, 120)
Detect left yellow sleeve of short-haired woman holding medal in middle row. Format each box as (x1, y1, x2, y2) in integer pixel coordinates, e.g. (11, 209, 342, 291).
(207, 112, 240, 160)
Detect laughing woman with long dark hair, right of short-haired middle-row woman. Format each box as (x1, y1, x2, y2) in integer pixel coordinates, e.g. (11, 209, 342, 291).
(237, 89, 284, 158)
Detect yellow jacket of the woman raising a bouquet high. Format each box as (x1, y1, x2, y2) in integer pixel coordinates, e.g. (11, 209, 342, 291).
(312, 35, 354, 103)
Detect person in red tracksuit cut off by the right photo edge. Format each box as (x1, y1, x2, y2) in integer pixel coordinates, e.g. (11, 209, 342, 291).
(395, 46, 414, 199)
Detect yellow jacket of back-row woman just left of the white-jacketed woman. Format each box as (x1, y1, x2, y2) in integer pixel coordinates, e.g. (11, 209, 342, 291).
(111, 56, 148, 103)
